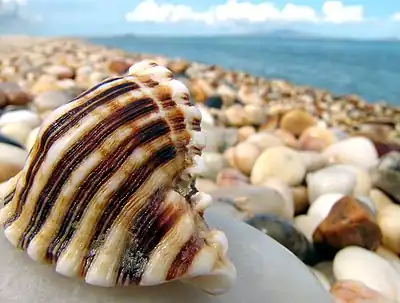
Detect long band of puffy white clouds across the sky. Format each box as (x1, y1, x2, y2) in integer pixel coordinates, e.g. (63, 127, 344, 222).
(125, 0, 364, 24)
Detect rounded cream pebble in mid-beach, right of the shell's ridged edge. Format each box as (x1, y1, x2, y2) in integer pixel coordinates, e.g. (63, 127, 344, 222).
(250, 146, 306, 186)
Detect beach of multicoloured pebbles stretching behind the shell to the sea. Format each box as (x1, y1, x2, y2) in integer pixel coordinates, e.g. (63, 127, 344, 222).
(0, 36, 400, 303)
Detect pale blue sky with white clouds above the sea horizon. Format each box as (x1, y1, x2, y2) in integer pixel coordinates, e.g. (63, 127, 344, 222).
(0, 0, 400, 38)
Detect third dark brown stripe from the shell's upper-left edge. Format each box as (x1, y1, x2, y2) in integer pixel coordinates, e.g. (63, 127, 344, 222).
(47, 120, 170, 262)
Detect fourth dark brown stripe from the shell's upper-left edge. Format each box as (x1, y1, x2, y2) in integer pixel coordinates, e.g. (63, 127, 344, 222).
(82, 144, 176, 276)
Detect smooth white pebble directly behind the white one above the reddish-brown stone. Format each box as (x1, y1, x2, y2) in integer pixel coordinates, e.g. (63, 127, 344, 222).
(322, 137, 378, 169)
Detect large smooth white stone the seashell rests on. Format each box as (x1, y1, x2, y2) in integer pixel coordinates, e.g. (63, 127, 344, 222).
(0, 212, 333, 303)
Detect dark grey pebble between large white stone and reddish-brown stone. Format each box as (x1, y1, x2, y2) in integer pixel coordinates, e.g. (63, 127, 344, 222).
(246, 214, 315, 264)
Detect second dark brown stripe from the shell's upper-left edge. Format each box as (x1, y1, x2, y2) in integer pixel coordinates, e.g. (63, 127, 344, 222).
(19, 98, 158, 249)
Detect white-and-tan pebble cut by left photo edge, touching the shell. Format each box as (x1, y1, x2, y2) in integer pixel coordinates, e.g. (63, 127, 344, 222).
(0, 143, 28, 182)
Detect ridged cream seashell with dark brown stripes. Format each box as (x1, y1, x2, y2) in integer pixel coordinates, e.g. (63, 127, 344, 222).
(0, 61, 236, 294)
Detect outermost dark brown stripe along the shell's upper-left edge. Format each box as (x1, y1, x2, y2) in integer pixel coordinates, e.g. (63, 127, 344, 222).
(4, 80, 139, 228)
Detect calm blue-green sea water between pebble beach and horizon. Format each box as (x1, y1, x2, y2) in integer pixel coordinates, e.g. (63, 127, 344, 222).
(89, 36, 400, 106)
